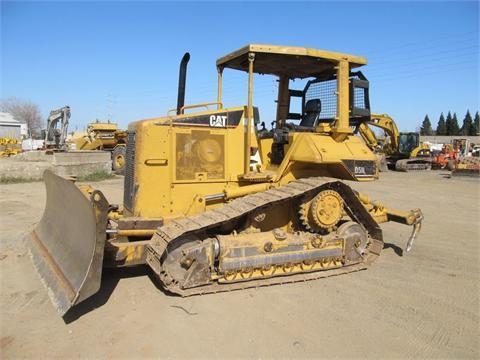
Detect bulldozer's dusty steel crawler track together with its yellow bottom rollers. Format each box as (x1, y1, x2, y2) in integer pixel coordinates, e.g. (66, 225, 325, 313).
(147, 177, 383, 296)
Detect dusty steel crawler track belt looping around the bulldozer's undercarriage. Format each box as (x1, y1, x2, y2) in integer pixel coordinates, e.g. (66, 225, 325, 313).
(147, 177, 383, 296)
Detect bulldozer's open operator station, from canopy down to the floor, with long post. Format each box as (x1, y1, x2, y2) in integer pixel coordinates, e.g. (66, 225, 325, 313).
(217, 44, 376, 170)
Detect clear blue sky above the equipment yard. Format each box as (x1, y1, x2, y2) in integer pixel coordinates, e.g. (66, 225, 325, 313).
(0, 0, 480, 131)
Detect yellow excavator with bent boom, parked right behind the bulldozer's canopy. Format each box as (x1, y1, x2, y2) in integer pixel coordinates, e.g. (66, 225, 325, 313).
(355, 114, 432, 171)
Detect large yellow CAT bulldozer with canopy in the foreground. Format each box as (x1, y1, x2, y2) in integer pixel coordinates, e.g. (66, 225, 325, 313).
(28, 45, 422, 315)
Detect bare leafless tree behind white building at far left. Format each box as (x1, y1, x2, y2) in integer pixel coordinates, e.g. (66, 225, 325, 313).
(0, 97, 43, 137)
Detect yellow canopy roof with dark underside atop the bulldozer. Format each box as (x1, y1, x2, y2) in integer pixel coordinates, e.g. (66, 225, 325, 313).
(217, 44, 367, 79)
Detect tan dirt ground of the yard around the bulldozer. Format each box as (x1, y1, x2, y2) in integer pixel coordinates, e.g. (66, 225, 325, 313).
(0, 171, 480, 359)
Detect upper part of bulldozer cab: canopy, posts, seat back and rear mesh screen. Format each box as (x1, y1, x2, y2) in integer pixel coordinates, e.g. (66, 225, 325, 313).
(217, 44, 370, 134)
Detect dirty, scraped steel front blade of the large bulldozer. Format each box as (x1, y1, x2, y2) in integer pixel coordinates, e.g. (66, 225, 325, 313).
(26, 170, 108, 316)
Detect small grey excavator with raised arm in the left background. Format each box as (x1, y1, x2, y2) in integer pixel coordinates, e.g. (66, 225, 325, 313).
(42, 106, 70, 150)
